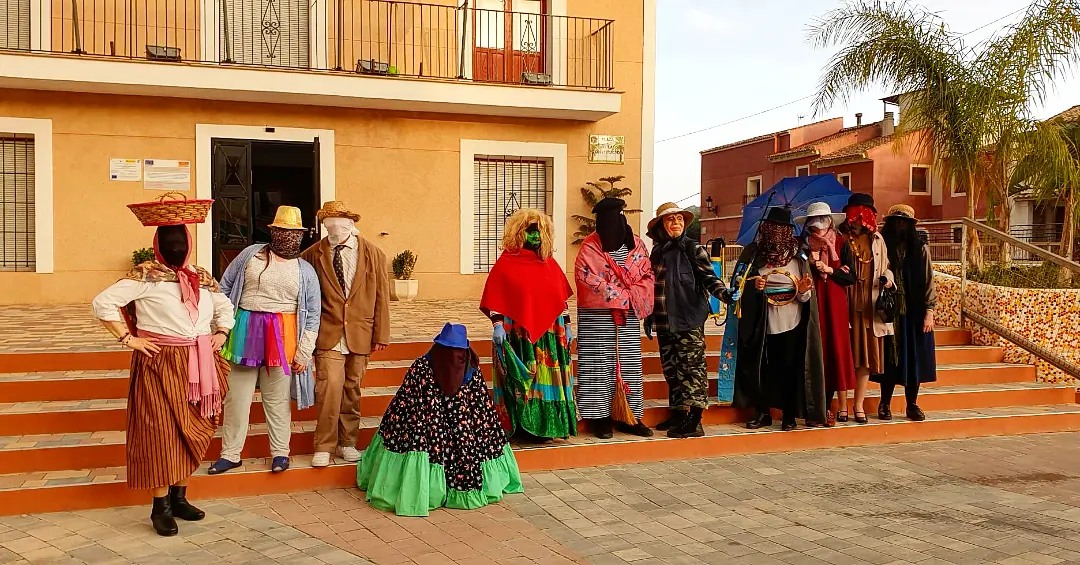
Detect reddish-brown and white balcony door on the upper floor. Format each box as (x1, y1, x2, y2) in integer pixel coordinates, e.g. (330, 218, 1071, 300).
(472, 0, 548, 82)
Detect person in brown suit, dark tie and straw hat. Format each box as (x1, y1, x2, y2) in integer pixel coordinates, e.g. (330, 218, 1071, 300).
(301, 201, 390, 467)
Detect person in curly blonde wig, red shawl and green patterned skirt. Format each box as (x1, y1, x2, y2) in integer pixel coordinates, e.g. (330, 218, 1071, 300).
(480, 210, 578, 442)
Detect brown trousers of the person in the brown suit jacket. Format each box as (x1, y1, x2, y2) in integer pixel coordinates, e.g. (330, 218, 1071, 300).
(314, 349, 367, 454)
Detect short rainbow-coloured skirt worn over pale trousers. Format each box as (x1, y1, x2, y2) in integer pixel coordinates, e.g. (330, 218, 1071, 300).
(221, 308, 297, 375)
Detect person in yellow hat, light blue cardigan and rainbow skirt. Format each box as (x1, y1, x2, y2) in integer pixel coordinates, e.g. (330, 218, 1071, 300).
(208, 206, 321, 474)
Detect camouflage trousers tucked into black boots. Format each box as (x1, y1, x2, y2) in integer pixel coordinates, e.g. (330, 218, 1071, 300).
(657, 328, 708, 408)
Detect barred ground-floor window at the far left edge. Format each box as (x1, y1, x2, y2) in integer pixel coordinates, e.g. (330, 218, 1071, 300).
(0, 133, 37, 272)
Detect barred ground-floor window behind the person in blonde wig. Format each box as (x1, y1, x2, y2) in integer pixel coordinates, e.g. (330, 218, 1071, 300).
(473, 157, 553, 272)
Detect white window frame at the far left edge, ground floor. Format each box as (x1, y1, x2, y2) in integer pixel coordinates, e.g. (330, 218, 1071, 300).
(0, 117, 55, 274)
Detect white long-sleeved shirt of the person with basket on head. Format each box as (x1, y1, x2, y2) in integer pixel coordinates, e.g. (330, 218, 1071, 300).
(93, 279, 235, 339)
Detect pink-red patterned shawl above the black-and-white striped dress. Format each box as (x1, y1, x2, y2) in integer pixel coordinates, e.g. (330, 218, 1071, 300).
(573, 233, 656, 320)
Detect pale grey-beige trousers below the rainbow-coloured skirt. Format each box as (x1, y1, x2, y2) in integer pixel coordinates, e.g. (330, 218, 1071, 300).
(221, 365, 293, 462)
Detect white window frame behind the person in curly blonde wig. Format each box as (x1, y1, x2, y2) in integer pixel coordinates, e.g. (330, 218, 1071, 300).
(458, 139, 569, 274)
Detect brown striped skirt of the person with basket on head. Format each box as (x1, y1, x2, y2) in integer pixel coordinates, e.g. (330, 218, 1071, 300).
(127, 347, 229, 488)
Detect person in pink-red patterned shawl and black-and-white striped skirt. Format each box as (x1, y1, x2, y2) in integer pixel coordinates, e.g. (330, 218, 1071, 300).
(573, 198, 654, 439)
